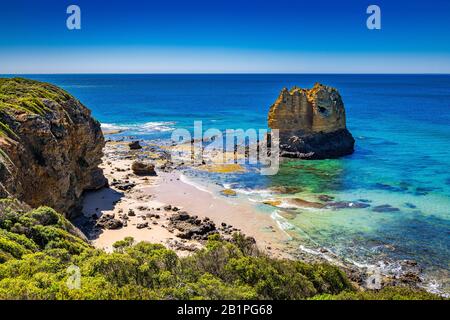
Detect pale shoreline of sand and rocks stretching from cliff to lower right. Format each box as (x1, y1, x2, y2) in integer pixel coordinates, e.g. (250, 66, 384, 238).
(77, 135, 440, 296)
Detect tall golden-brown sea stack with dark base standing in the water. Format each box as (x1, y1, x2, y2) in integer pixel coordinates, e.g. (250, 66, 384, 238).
(268, 83, 355, 159)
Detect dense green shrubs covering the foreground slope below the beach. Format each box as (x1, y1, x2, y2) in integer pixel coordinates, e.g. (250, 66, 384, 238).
(0, 200, 439, 299)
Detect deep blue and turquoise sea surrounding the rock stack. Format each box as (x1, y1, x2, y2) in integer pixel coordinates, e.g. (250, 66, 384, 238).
(14, 74, 450, 293)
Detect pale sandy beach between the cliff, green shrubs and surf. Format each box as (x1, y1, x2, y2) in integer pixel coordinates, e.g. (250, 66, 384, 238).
(83, 141, 290, 257)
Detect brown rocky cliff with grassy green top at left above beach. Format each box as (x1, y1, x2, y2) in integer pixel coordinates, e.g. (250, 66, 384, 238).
(0, 78, 107, 217)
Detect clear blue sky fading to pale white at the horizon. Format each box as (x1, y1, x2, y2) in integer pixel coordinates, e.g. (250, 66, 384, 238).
(0, 0, 450, 73)
